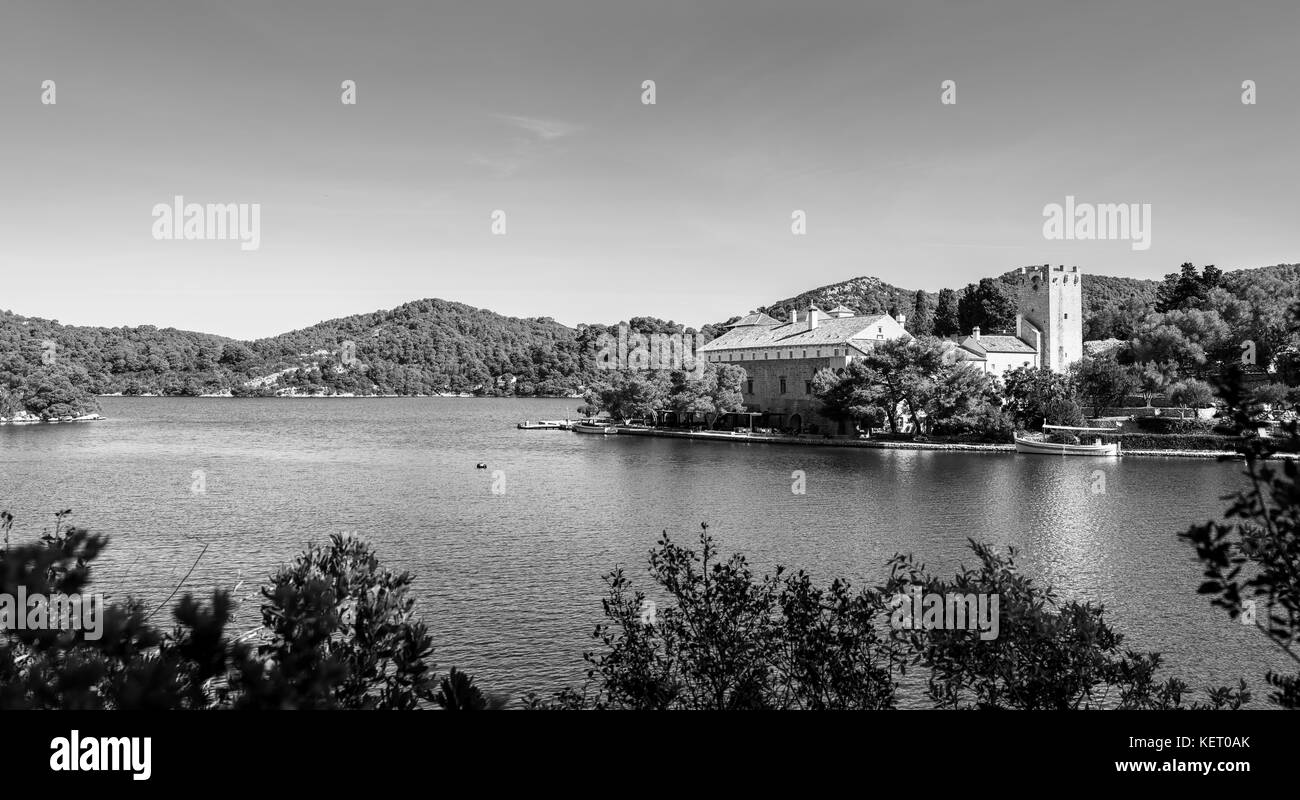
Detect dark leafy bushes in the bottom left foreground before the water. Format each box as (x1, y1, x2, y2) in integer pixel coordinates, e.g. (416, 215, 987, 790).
(0, 511, 501, 709)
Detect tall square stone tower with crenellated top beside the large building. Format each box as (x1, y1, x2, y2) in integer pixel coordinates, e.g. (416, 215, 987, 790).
(1017, 264, 1083, 372)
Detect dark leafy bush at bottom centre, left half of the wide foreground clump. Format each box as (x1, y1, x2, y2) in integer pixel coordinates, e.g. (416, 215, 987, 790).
(528, 526, 896, 710)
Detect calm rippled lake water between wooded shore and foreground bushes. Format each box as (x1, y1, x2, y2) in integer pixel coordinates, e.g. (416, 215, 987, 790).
(0, 398, 1284, 697)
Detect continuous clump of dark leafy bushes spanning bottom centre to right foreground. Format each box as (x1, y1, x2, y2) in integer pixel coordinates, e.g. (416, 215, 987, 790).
(525, 526, 1251, 710)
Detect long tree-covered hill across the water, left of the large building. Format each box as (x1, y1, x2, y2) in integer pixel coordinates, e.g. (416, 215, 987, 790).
(0, 299, 618, 403)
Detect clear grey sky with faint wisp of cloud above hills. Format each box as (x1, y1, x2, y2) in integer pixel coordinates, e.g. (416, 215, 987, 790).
(0, 0, 1300, 338)
